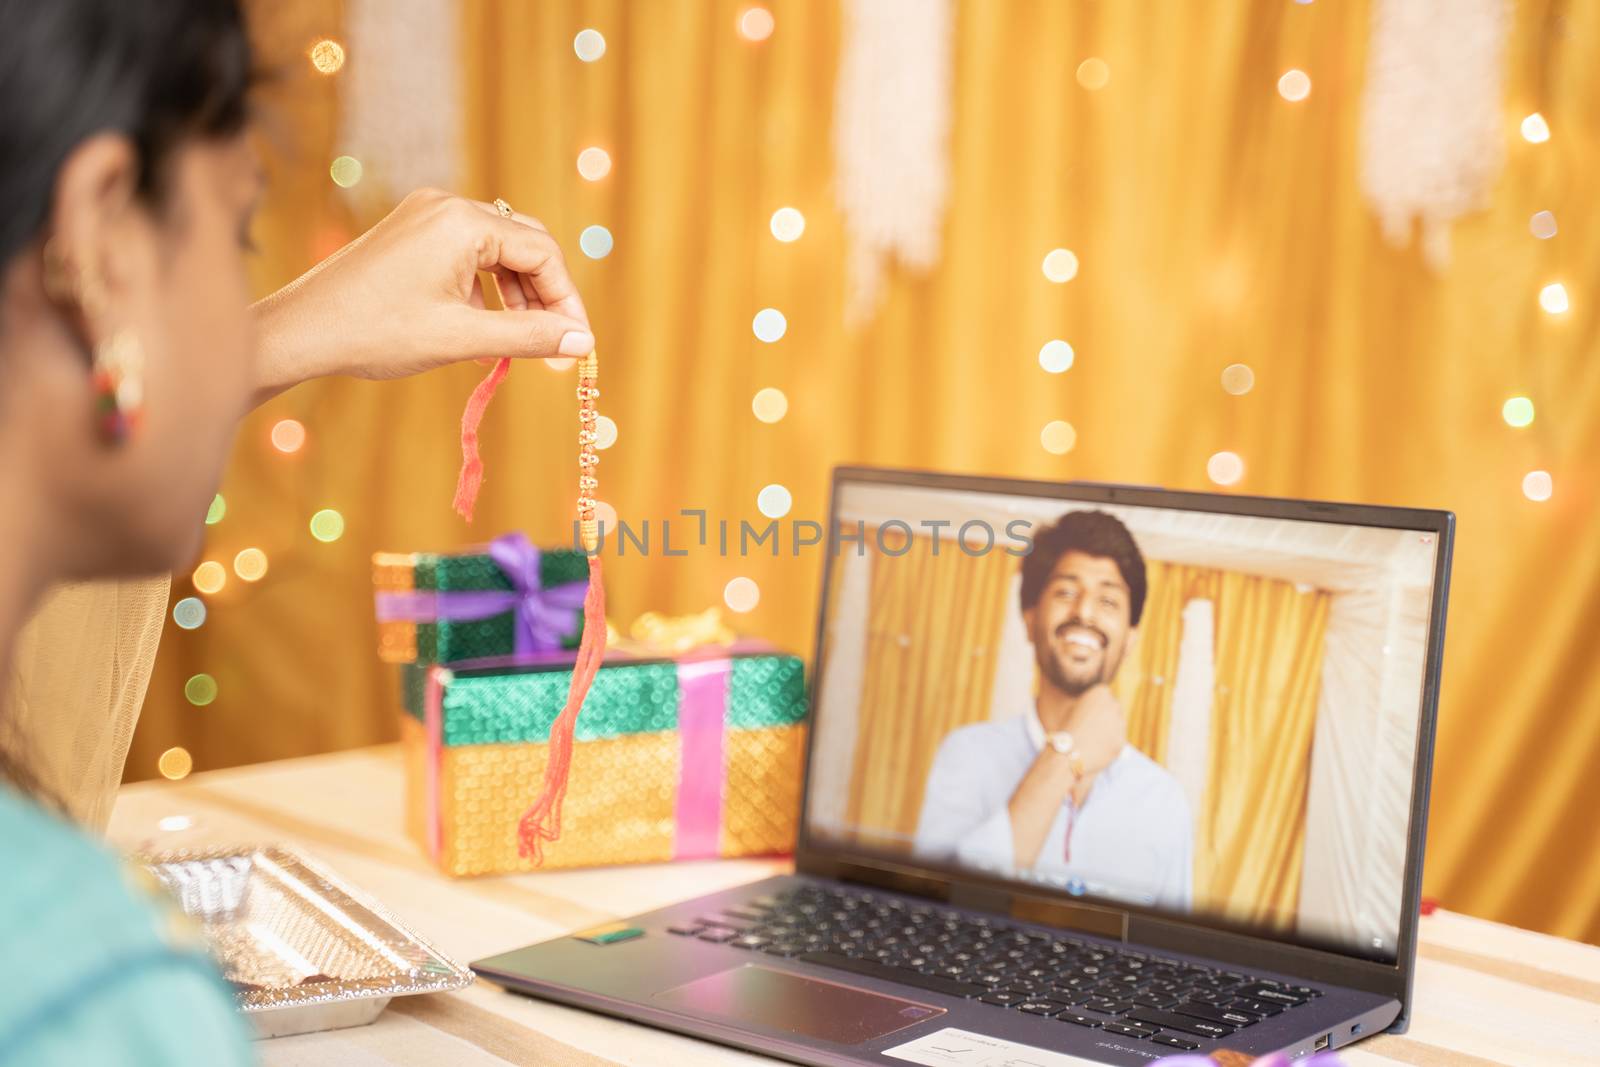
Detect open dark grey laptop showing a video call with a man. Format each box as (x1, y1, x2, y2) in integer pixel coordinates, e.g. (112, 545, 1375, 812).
(474, 467, 1454, 1067)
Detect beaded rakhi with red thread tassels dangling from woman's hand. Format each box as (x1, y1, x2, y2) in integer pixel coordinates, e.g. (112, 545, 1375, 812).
(454, 352, 606, 867)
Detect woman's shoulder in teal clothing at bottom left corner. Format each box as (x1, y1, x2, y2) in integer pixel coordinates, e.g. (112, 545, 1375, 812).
(0, 787, 250, 1067)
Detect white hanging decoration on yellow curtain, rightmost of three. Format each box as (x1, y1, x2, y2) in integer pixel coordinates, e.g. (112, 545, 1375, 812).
(1362, 0, 1510, 270)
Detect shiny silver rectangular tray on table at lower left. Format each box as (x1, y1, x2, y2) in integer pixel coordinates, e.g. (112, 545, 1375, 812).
(139, 848, 472, 1037)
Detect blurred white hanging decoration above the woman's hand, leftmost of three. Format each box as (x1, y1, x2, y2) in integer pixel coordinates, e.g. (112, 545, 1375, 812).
(338, 0, 462, 200)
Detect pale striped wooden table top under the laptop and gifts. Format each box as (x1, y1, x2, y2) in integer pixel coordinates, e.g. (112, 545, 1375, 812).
(110, 745, 1600, 1067)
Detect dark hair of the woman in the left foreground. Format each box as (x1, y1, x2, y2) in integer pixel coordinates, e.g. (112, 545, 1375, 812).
(0, 0, 251, 266)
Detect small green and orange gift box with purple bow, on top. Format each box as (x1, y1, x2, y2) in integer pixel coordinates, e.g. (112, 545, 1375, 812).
(373, 533, 589, 664)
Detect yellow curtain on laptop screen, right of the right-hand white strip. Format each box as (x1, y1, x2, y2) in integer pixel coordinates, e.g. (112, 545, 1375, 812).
(1195, 573, 1331, 928)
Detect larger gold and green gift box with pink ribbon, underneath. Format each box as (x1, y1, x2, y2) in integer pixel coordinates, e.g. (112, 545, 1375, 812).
(402, 643, 806, 875)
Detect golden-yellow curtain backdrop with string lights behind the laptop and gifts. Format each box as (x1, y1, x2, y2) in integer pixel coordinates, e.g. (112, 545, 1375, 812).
(130, 0, 1600, 941)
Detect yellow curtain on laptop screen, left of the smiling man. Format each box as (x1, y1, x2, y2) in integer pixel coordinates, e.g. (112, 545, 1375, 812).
(845, 530, 1018, 845)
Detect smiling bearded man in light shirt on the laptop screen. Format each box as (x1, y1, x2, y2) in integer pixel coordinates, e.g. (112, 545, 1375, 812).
(915, 512, 1194, 910)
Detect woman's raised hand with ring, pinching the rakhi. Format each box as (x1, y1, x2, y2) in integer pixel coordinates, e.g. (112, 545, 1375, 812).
(253, 189, 595, 403)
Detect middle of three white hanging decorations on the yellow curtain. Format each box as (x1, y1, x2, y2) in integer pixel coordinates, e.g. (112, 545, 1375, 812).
(834, 0, 954, 323)
